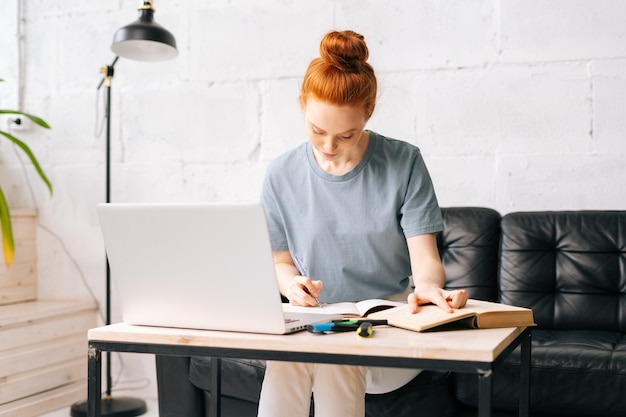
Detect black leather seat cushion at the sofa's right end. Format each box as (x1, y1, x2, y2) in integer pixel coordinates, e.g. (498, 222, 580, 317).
(455, 329, 626, 417)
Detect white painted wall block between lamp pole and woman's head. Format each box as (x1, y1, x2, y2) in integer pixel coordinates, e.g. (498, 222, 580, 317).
(119, 82, 260, 164)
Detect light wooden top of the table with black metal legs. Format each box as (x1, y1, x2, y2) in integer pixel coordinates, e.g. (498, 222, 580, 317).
(88, 323, 525, 362)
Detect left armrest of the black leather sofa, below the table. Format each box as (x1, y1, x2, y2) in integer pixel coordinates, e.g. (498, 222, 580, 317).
(156, 355, 203, 417)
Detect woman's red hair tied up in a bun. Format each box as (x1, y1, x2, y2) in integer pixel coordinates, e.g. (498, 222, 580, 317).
(300, 30, 377, 119)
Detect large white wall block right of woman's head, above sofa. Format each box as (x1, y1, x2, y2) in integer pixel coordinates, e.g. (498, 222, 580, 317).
(415, 64, 591, 155)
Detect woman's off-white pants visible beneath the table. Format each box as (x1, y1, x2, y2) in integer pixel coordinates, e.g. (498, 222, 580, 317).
(258, 361, 367, 417)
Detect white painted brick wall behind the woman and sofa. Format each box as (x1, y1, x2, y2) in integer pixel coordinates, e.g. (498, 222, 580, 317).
(0, 0, 626, 406)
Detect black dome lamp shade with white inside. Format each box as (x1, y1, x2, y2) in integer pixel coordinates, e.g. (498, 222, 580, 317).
(111, 9, 178, 61)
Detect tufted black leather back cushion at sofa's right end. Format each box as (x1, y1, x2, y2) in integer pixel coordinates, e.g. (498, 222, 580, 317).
(499, 211, 626, 333)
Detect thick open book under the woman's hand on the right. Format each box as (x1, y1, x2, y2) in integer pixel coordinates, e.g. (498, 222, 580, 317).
(369, 299, 535, 332)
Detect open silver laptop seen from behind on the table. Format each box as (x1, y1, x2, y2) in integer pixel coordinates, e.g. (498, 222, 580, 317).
(97, 203, 339, 334)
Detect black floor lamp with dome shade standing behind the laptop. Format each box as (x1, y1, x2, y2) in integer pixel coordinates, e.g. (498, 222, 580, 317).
(71, 0, 178, 417)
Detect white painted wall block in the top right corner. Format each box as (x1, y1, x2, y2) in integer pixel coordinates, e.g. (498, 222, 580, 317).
(499, 0, 626, 62)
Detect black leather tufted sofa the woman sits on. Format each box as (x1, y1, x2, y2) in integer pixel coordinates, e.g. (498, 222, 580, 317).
(156, 207, 626, 417)
